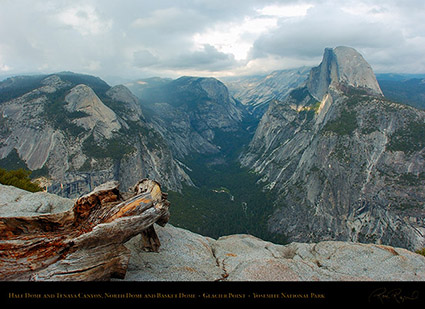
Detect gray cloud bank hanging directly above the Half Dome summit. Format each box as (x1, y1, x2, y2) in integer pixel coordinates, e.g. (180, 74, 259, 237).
(252, 5, 403, 58)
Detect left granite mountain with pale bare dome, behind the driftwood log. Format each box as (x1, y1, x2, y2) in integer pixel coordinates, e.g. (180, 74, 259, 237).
(0, 72, 190, 197)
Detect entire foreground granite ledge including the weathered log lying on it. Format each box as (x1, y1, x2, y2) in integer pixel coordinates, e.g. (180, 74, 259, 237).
(0, 180, 425, 281)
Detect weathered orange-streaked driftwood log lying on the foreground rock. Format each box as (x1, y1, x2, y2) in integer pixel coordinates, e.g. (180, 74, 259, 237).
(0, 179, 169, 281)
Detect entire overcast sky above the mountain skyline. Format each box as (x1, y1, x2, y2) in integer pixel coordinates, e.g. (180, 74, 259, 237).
(0, 0, 425, 82)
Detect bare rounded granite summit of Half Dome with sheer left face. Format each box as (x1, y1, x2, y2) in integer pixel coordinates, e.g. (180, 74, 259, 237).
(307, 46, 383, 100)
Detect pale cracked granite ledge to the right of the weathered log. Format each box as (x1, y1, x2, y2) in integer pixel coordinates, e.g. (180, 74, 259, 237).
(121, 224, 425, 281)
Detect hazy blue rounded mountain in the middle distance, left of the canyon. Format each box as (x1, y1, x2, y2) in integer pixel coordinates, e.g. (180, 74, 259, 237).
(129, 76, 246, 159)
